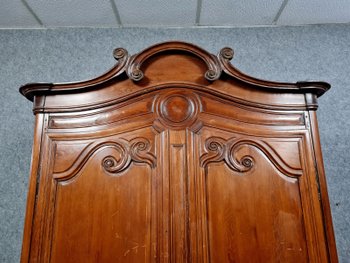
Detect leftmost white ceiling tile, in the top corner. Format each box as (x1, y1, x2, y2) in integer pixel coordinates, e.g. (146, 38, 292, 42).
(0, 0, 40, 28)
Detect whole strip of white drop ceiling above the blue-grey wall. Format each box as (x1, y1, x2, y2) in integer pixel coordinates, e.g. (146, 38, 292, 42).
(0, 0, 350, 28)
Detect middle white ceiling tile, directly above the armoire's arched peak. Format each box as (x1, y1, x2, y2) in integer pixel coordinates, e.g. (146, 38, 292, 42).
(115, 0, 197, 26)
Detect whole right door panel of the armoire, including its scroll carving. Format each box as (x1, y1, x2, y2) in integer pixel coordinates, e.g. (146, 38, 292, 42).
(200, 128, 310, 262)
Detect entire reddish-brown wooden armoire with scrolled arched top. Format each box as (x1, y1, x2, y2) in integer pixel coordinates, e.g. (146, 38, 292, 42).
(20, 41, 337, 263)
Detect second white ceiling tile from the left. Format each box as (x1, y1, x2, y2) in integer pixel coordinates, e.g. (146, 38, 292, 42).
(27, 0, 118, 27)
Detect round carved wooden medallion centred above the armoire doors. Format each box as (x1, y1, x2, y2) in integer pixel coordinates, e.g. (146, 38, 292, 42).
(153, 92, 202, 130)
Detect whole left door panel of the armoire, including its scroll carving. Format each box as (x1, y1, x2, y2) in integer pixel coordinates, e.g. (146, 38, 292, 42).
(31, 128, 158, 262)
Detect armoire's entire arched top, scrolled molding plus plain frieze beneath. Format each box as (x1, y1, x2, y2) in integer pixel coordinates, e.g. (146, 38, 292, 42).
(20, 41, 330, 112)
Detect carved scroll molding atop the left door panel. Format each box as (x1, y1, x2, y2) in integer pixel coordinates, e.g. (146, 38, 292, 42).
(53, 137, 156, 180)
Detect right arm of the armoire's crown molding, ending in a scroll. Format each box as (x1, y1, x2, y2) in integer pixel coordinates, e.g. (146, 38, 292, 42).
(218, 47, 331, 97)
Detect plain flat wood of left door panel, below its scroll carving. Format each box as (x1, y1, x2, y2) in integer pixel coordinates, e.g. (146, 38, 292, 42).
(51, 163, 153, 262)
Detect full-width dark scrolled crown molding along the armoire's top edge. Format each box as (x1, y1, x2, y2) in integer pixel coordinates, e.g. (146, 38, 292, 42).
(20, 41, 330, 101)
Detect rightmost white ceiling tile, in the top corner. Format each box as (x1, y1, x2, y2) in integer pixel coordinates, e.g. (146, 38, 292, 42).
(277, 0, 350, 25)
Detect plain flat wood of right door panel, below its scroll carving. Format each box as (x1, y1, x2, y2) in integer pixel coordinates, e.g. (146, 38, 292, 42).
(206, 156, 308, 262)
